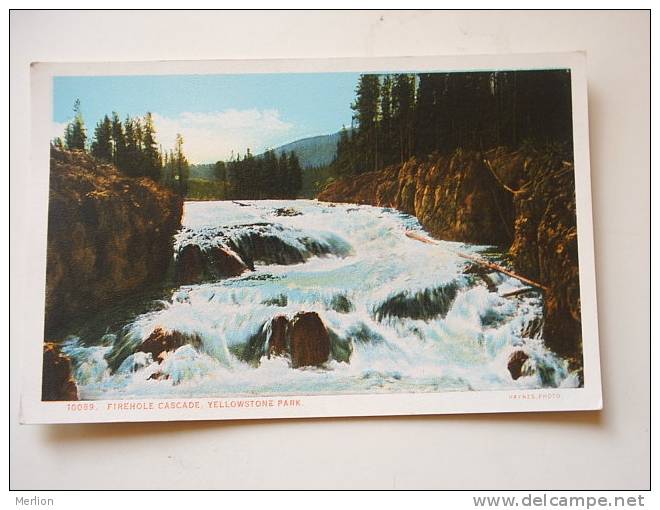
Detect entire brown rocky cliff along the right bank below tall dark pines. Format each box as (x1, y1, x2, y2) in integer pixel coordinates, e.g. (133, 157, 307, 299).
(318, 147, 582, 366)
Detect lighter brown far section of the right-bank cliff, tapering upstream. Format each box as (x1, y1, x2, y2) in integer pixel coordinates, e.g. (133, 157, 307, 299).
(318, 150, 514, 245)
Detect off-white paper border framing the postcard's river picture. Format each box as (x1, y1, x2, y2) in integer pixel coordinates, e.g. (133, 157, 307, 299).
(20, 52, 602, 423)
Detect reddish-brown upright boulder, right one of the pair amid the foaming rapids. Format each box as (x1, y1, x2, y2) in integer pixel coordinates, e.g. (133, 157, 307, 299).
(290, 312, 330, 368)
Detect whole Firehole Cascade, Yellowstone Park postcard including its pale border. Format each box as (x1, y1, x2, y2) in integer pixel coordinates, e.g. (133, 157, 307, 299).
(20, 53, 602, 423)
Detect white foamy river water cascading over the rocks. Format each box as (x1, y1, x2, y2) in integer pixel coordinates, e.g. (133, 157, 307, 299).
(63, 200, 578, 399)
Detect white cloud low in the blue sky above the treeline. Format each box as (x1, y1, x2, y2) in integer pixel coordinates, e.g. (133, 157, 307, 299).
(153, 109, 293, 163)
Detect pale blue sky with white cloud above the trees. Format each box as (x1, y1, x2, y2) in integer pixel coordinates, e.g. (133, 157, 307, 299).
(53, 73, 359, 163)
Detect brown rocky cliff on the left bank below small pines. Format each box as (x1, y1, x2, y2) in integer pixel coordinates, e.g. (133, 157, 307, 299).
(45, 150, 183, 338)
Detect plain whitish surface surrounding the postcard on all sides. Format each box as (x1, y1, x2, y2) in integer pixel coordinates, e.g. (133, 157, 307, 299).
(10, 11, 650, 489)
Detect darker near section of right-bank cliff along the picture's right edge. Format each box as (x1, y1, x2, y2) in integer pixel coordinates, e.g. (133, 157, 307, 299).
(502, 150, 582, 360)
